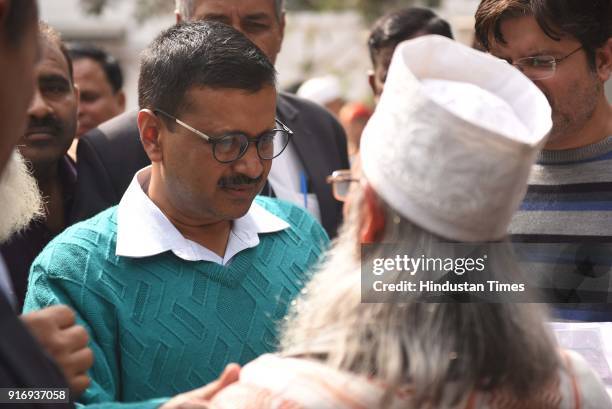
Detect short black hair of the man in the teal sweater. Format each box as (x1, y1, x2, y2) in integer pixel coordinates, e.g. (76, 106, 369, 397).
(138, 21, 276, 115)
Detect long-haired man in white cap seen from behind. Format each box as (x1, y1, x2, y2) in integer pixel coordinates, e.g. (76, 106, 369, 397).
(198, 36, 612, 409)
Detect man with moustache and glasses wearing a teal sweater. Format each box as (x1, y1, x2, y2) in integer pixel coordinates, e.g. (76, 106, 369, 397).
(25, 22, 328, 408)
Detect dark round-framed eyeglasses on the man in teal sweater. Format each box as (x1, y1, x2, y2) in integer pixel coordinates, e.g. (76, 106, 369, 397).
(153, 109, 293, 163)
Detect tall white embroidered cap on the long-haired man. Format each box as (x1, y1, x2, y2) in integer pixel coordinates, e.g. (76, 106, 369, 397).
(361, 36, 552, 242)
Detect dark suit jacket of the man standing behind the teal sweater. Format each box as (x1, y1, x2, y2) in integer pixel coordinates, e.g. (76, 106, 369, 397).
(74, 93, 349, 237)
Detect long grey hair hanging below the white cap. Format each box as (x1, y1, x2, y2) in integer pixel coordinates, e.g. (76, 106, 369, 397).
(281, 190, 560, 408)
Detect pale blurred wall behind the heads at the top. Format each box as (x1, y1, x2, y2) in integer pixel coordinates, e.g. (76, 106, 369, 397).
(41, 0, 478, 109)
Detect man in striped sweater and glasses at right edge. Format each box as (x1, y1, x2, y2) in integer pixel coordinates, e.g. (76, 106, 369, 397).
(476, 0, 612, 321)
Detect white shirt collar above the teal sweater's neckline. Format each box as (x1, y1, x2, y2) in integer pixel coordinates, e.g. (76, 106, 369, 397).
(115, 166, 289, 265)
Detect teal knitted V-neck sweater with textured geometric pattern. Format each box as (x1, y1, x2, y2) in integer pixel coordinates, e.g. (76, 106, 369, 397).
(24, 197, 328, 409)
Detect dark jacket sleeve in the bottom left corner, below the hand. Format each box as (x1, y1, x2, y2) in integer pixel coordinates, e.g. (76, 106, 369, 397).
(0, 293, 73, 409)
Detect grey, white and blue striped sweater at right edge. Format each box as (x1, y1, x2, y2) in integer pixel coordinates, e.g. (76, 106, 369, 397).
(510, 136, 612, 321)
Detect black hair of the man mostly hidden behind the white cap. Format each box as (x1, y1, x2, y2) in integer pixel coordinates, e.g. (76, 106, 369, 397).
(368, 7, 453, 64)
